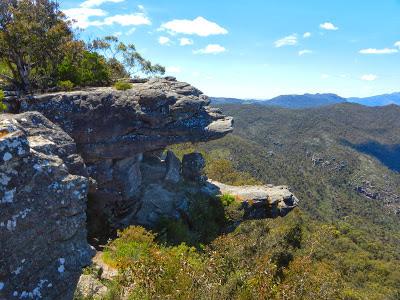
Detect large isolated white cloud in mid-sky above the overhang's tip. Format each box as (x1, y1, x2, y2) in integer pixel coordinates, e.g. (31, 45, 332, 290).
(159, 17, 228, 36)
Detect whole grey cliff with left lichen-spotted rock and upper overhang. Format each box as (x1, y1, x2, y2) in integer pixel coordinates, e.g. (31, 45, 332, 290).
(0, 78, 297, 299)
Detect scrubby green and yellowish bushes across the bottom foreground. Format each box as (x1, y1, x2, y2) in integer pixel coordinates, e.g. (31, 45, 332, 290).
(78, 210, 399, 299)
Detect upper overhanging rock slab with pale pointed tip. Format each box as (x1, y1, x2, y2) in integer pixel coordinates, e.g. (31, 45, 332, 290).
(21, 77, 233, 161)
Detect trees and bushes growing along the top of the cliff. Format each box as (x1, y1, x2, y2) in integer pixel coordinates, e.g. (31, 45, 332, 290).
(0, 0, 165, 93)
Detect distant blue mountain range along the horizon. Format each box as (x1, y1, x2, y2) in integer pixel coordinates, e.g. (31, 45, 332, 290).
(211, 93, 400, 109)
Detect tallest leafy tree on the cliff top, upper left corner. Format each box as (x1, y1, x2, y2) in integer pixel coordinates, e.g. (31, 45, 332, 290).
(0, 0, 73, 92)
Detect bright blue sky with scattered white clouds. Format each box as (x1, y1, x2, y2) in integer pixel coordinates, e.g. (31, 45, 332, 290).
(59, 0, 400, 99)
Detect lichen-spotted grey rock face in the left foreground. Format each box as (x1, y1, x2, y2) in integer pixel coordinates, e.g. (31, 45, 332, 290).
(0, 112, 93, 299)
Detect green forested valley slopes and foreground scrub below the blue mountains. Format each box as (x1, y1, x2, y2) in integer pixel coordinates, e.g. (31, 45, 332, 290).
(81, 104, 400, 300)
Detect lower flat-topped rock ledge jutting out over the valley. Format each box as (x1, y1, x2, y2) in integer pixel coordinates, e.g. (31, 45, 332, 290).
(203, 180, 299, 220)
